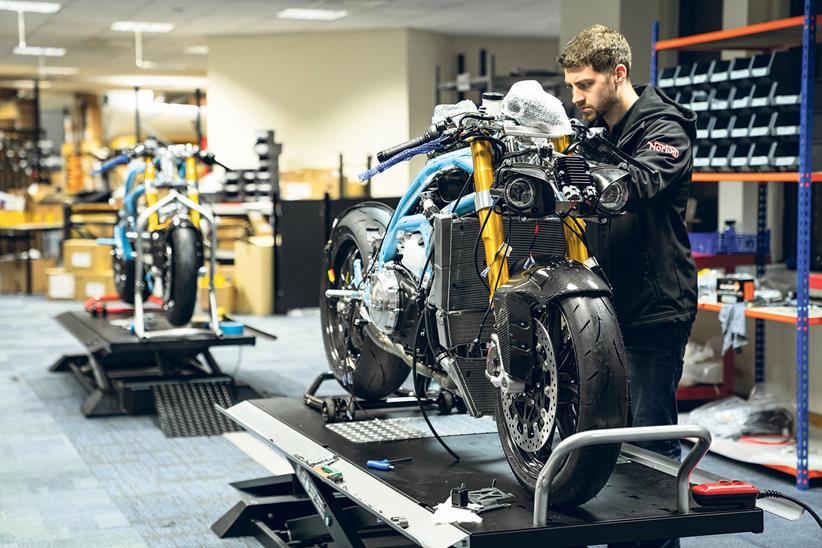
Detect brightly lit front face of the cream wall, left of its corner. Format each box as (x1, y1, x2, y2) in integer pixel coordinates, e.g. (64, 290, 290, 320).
(208, 30, 409, 195)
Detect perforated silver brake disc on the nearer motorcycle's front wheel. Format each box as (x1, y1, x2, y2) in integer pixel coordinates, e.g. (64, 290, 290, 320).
(501, 321, 557, 453)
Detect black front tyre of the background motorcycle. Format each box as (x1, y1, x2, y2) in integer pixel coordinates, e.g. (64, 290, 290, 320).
(166, 228, 202, 326)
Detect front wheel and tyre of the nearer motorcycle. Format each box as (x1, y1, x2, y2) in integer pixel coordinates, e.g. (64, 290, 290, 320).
(496, 295, 628, 507)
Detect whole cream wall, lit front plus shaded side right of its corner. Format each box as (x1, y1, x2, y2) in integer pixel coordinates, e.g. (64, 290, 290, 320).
(207, 29, 557, 196)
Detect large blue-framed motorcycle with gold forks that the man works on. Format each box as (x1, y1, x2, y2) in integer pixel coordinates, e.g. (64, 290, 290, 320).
(320, 81, 630, 506)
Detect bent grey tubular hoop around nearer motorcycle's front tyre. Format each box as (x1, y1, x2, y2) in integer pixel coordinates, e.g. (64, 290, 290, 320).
(534, 425, 711, 527)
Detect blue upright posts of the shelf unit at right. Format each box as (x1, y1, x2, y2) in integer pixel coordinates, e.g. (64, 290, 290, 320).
(650, 0, 816, 490)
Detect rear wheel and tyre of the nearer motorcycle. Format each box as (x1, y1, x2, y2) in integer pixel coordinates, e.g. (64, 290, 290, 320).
(320, 202, 410, 400)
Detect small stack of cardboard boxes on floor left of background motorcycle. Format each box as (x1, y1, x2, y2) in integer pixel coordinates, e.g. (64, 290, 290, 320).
(48, 240, 115, 300)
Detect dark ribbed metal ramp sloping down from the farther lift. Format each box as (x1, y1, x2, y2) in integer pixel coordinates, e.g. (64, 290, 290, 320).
(151, 381, 242, 438)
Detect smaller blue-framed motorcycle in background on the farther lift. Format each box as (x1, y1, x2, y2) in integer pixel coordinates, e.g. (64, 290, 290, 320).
(95, 139, 225, 338)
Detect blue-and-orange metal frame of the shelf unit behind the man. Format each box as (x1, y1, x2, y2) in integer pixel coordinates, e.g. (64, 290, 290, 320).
(651, 0, 822, 490)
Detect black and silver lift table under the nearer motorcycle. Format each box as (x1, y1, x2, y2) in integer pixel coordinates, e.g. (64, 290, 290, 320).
(212, 398, 764, 548)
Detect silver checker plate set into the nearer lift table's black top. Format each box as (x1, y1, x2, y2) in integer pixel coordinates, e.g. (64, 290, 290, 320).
(326, 415, 497, 443)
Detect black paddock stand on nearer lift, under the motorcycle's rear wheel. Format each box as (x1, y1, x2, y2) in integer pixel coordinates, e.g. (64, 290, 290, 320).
(303, 371, 465, 423)
